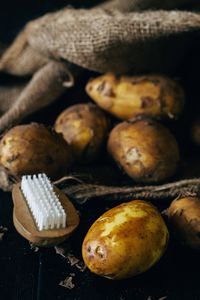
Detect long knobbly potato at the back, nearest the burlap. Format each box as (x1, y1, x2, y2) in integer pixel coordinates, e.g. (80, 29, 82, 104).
(86, 73, 185, 120)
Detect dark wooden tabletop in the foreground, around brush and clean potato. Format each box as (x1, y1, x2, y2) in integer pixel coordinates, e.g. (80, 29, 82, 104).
(0, 185, 200, 300)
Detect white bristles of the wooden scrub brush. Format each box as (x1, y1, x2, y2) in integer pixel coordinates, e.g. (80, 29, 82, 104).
(21, 174, 67, 230)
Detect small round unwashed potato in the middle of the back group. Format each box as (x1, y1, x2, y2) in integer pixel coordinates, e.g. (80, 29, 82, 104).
(55, 104, 109, 162)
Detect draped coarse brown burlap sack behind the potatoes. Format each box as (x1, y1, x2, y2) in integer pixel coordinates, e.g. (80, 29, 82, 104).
(0, 0, 200, 131)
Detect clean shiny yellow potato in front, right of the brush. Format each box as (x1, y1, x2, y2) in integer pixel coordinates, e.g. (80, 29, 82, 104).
(82, 200, 169, 279)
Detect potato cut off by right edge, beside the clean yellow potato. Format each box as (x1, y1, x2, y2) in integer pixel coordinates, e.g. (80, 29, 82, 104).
(167, 197, 200, 249)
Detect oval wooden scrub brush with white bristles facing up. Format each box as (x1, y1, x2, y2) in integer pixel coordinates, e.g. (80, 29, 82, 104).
(12, 174, 79, 246)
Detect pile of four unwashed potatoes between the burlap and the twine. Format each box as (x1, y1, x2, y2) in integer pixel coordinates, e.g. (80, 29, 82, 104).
(0, 74, 184, 182)
